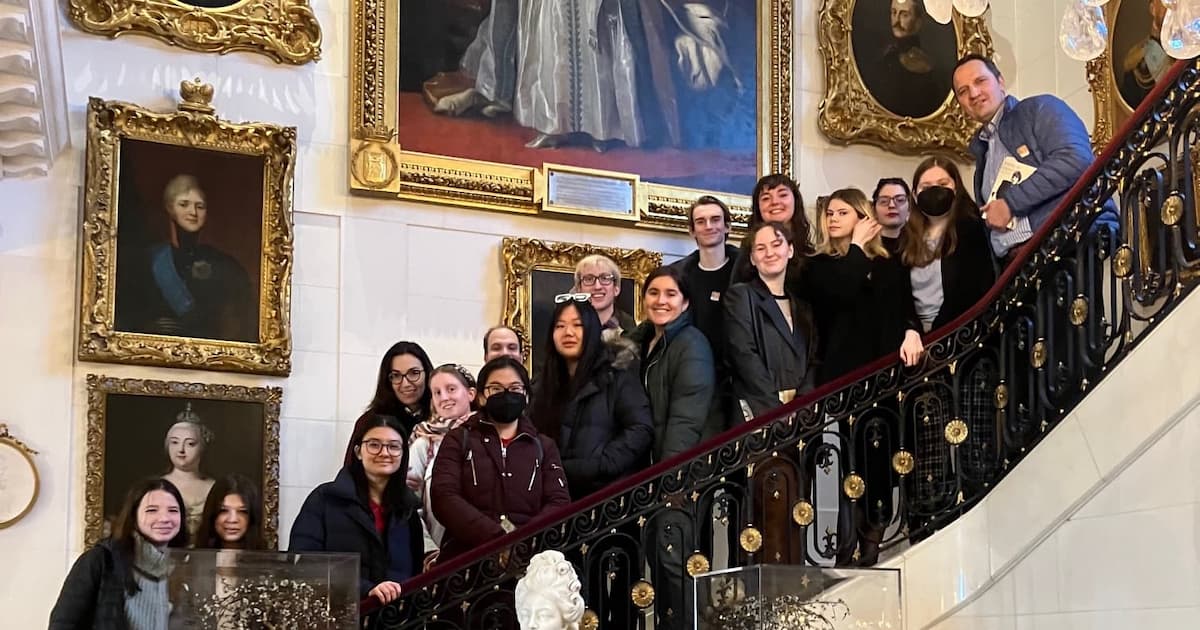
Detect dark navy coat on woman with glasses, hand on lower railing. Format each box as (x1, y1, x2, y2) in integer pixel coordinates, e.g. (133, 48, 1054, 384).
(288, 468, 425, 598)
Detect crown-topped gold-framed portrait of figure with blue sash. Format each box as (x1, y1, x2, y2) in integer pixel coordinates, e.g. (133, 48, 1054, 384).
(78, 79, 296, 376)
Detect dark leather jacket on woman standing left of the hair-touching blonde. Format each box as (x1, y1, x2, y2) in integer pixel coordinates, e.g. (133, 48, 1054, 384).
(724, 277, 816, 418)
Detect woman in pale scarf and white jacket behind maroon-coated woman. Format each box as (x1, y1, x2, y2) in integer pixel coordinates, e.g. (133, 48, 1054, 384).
(408, 364, 475, 565)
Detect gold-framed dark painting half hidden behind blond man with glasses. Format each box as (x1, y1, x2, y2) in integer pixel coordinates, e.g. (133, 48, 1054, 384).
(500, 236, 662, 373)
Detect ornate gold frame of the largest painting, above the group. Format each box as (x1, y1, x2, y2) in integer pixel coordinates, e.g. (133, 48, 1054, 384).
(348, 0, 794, 232)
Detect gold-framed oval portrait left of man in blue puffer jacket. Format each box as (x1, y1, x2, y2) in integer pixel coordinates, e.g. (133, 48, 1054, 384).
(817, 0, 994, 158)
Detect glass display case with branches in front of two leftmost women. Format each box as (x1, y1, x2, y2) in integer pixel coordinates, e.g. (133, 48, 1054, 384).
(167, 550, 359, 630)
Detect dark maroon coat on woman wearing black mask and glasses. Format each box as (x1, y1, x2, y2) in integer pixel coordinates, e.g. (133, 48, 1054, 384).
(430, 412, 571, 562)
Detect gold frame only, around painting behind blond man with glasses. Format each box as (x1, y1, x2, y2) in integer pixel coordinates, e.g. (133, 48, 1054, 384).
(500, 236, 662, 367)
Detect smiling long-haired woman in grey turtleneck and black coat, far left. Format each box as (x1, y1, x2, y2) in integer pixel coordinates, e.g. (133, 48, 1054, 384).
(49, 479, 187, 630)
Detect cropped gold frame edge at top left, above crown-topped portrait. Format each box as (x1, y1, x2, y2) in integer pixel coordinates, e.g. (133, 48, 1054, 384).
(67, 0, 320, 65)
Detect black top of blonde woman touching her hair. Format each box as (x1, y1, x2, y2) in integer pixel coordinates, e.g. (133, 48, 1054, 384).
(803, 245, 920, 384)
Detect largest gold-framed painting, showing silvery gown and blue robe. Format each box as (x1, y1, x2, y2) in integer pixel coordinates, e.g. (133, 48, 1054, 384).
(350, 0, 792, 229)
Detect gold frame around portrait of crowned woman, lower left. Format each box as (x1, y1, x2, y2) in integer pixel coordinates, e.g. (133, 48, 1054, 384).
(84, 374, 283, 550)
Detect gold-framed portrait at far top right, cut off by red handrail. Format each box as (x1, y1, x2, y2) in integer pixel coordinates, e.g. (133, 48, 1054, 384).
(1087, 0, 1175, 151)
